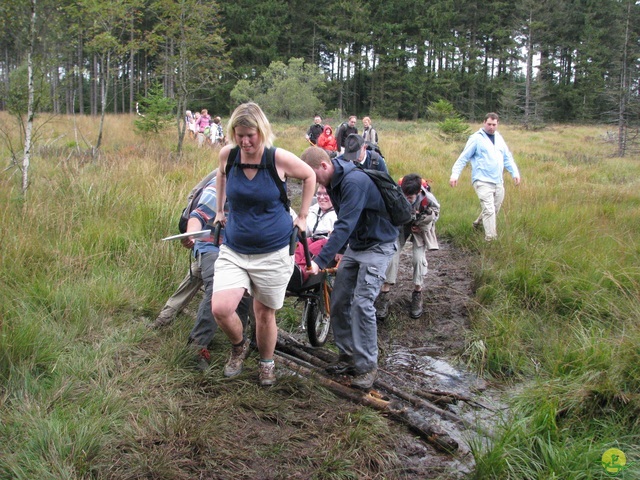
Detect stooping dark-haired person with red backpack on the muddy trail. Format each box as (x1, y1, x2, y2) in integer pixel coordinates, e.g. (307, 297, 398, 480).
(376, 173, 440, 320)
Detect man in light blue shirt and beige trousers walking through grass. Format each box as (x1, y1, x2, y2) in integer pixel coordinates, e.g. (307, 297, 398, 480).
(449, 113, 520, 242)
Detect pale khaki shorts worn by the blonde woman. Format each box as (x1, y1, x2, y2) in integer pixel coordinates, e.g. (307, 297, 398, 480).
(213, 244, 294, 310)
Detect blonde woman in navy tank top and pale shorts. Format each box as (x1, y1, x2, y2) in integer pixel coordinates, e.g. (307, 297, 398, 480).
(211, 103, 316, 386)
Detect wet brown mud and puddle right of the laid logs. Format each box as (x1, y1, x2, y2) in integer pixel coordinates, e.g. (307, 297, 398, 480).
(284, 241, 504, 479)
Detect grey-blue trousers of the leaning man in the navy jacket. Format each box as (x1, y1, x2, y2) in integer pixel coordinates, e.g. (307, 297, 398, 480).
(331, 242, 398, 374)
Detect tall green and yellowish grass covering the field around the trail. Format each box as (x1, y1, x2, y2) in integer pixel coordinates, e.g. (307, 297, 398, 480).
(0, 110, 640, 479)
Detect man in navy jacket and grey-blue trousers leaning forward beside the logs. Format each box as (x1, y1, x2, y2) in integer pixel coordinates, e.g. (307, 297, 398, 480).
(301, 147, 398, 389)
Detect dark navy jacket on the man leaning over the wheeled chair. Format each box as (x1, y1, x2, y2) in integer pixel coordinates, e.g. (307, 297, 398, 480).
(314, 158, 399, 268)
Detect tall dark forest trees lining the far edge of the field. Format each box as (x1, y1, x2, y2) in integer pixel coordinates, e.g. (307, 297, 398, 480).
(0, 0, 640, 124)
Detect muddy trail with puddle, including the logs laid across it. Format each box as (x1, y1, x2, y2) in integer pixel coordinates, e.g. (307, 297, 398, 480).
(277, 242, 504, 479)
